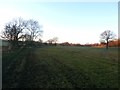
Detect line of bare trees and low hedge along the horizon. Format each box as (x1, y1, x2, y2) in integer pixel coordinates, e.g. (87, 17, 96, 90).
(1, 18, 116, 49)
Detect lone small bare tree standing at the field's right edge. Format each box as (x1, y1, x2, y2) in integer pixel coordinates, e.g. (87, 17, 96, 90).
(100, 30, 115, 49)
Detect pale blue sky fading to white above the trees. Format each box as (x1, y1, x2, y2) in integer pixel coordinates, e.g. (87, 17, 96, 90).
(0, 0, 118, 44)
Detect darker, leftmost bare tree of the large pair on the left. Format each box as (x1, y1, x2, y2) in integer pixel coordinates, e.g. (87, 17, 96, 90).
(2, 18, 25, 41)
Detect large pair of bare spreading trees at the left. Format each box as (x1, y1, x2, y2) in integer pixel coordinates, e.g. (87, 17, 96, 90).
(1, 18, 42, 45)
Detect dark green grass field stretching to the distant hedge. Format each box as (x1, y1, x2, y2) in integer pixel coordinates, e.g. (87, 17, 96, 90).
(2, 46, 118, 88)
